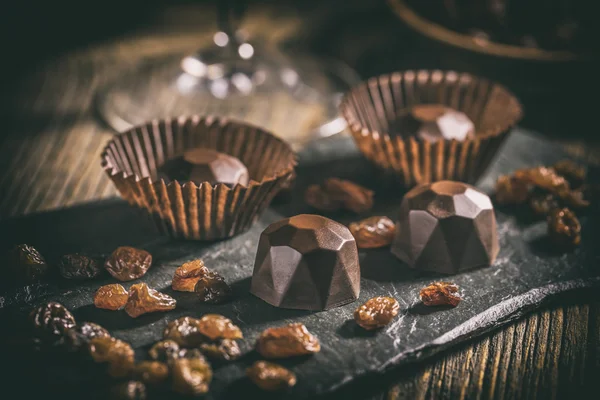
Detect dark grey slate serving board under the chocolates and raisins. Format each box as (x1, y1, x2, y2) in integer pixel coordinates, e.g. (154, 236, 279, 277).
(0, 131, 600, 399)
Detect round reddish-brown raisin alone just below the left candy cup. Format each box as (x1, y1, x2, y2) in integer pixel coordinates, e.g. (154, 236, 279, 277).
(104, 246, 152, 281)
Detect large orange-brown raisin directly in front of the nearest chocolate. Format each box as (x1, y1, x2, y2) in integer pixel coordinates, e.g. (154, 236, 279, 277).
(256, 323, 321, 358)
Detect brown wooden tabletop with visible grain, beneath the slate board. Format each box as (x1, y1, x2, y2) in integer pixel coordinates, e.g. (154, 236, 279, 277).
(0, 1, 600, 399)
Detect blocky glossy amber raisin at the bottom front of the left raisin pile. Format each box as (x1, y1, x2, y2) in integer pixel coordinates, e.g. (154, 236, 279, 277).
(171, 358, 212, 396)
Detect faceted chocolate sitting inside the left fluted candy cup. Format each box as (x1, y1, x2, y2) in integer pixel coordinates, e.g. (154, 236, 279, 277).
(159, 148, 249, 186)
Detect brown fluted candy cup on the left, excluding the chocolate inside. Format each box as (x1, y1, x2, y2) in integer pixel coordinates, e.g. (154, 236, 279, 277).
(101, 116, 296, 240)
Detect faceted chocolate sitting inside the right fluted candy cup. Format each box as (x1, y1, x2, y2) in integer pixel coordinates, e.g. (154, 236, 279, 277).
(390, 104, 475, 142)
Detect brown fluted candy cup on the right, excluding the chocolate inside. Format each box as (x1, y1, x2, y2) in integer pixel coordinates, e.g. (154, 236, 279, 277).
(340, 71, 523, 187)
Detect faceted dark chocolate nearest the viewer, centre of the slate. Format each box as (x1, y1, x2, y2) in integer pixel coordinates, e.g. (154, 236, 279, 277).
(250, 214, 360, 310)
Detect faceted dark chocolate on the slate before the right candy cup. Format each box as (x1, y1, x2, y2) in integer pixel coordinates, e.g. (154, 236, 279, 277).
(392, 181, 500, 274)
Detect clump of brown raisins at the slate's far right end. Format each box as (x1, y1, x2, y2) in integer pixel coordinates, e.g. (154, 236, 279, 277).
(496, 160, 590, 249)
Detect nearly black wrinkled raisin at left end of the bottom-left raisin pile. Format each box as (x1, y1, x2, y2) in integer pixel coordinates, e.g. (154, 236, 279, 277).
(29, 302, 76, 344)
